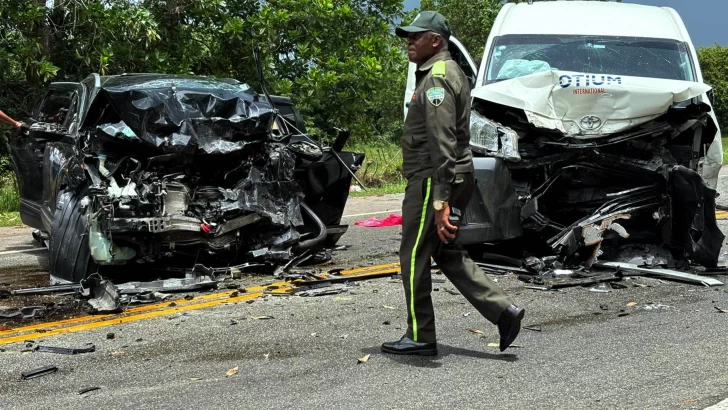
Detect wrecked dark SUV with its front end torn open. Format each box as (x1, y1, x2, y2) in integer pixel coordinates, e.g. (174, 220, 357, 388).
(9, 74, 364, 283)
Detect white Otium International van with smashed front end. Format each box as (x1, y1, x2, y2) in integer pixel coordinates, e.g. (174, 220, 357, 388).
(405, 1, 723, 267)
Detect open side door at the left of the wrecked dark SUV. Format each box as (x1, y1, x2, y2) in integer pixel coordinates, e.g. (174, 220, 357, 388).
(8, 83, 81, 231)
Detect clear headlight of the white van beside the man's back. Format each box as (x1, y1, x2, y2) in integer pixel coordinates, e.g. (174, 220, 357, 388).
(470, 110, 521, 161)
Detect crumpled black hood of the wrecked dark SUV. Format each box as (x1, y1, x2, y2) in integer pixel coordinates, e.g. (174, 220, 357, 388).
(79, 74, 275, 154)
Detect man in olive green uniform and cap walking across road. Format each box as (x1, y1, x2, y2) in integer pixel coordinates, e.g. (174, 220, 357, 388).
(382, 11, 524, 356)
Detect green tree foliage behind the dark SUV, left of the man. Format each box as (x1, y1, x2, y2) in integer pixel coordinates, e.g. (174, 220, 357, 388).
(0, 0, 406, 143)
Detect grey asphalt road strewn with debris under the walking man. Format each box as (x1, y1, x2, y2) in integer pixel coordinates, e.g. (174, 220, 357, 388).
(0, 171, 728, 409)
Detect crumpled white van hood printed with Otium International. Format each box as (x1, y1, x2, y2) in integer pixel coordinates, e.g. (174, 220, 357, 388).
(472, 70, 710, 139)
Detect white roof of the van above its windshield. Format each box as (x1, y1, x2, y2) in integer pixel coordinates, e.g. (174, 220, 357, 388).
(493, 1, 687, 41)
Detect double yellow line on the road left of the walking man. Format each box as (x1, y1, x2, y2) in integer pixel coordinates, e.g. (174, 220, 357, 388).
(0, 263, 399, 345)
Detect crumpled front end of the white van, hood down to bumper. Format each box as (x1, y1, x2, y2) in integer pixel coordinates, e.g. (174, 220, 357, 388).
(459, 72, 724, 268)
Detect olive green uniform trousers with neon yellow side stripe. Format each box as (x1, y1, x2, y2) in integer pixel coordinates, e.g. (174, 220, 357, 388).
(399, 173, 513, 343)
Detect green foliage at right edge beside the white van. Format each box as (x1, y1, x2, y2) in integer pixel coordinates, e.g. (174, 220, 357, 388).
(698, 44, 728, 133)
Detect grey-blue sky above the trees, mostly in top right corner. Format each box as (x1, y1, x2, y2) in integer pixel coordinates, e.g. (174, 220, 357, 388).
(404, 0, 728, 47)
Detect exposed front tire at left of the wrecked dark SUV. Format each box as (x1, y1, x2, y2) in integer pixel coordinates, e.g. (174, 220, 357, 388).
(48, 189, 98, 283)
